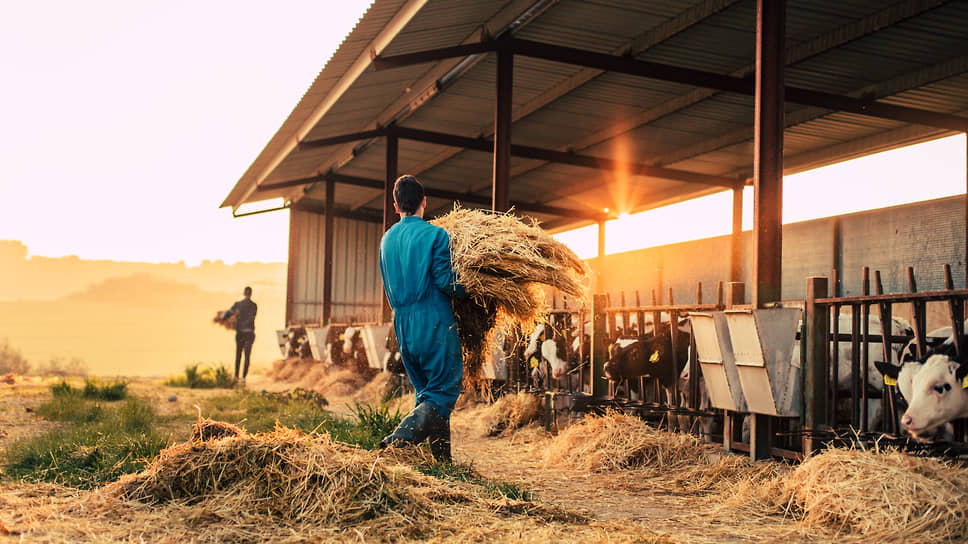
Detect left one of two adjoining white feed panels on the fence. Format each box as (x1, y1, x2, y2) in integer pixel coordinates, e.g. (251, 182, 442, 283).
(689, 312, 748, 412)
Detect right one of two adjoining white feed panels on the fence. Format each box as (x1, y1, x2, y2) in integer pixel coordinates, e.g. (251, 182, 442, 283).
(725, 308, 801, 417)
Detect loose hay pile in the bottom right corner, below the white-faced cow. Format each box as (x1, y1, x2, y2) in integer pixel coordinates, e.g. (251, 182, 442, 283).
(725, 449, 968, 542)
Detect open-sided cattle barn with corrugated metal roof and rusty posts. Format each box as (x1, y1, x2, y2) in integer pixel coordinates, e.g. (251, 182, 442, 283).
(222, 0, 968, 457)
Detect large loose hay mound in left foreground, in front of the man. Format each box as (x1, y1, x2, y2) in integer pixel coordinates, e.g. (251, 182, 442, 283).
(114, 428, 433, 525)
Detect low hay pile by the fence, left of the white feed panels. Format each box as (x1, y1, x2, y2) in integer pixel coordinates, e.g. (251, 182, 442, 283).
(544, 412, 706, 472)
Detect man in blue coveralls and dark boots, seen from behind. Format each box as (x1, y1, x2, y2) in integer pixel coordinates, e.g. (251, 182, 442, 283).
(380, 176, 467, 462)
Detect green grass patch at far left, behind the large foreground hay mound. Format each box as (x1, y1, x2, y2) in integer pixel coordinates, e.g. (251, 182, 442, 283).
(3, 394, 170, 489)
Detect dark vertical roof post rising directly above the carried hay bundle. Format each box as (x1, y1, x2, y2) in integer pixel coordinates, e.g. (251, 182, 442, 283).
(491, 50, 514, 212)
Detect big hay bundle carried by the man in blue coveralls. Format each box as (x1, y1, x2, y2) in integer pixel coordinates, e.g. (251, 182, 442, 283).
(432, 208, 589, 385)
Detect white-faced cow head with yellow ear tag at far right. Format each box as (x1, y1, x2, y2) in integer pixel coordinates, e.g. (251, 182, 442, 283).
(877, 327, 968, 442)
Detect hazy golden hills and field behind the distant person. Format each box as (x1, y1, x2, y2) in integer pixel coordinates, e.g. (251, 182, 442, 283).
(0, 245, 286, 376)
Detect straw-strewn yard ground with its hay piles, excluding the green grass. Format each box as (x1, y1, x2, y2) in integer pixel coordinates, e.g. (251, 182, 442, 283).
(0, 368, 968, 543)
